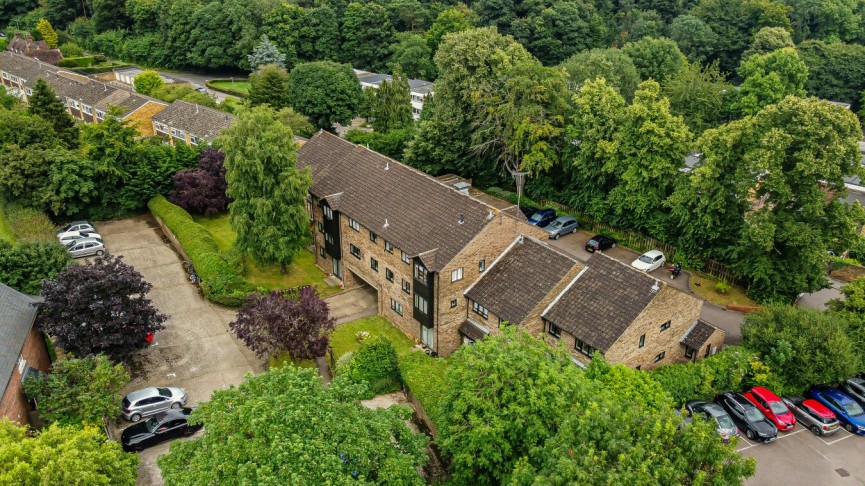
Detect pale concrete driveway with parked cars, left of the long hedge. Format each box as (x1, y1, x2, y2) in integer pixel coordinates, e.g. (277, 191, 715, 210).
(97, 215, 265, 485)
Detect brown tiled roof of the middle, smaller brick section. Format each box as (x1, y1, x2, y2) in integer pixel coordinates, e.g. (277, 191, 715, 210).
(466, 236, 582, 324)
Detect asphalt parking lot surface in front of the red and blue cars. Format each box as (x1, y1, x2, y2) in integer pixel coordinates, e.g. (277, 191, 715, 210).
(736, 424, 865, 486)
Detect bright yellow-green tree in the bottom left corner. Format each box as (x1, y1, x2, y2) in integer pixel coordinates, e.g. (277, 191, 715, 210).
(0, 417, 138, 486)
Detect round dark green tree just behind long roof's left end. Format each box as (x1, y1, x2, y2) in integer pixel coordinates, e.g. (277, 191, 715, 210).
(288, 61, 361, 130)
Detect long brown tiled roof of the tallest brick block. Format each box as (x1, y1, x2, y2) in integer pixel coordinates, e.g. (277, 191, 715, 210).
(297, 132, 506, 272)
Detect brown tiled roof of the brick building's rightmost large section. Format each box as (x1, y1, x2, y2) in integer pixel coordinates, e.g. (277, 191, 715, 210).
(543, 253, 666, 352)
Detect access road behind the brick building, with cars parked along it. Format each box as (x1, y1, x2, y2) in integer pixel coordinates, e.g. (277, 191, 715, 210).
(550, 230, 745, 344)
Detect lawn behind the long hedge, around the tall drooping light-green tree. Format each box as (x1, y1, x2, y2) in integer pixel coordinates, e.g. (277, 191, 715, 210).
(193, 214, 340, 297)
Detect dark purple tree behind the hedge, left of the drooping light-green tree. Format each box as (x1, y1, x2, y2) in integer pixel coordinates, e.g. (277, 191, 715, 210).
(168, 148, 231, 216)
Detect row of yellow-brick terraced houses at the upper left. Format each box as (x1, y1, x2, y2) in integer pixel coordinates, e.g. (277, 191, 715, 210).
(0, 51, 234, 145)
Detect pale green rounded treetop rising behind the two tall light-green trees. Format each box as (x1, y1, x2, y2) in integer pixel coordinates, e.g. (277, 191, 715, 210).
(562, 49, 640, 101)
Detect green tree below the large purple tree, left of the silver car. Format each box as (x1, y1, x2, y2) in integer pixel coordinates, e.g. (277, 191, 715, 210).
(24, 355, 130, 426)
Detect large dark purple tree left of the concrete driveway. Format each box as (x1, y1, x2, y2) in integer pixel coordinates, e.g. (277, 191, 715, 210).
(37, 256, 167, 361)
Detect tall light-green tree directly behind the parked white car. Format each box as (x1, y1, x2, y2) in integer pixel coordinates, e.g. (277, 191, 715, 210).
(608, 80, 692, 236)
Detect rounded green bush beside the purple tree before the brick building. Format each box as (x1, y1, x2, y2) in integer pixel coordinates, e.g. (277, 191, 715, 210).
(340, 336, 401, 398)
